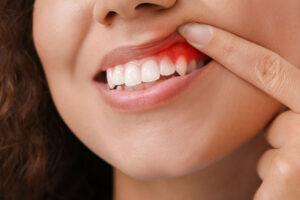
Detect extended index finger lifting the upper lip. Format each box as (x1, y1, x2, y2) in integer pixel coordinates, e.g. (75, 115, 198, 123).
(179, 23, 300, 113)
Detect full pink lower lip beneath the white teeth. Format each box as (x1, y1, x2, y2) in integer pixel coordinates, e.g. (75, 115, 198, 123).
(95, 63, 210, 112)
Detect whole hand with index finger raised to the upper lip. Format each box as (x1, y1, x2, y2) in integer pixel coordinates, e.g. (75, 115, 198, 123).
(179, 23, 300, 200)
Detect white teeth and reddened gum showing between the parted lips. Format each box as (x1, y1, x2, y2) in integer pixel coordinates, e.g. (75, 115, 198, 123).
(95, 42, 212, 91)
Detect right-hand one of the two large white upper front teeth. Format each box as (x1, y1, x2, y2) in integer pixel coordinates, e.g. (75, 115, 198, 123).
(142, 59, 160, 82)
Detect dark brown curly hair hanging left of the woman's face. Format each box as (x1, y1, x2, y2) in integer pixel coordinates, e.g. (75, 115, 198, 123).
(0, 0, 112, 200)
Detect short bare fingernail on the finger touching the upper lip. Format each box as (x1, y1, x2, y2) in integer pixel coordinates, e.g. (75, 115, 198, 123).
(178, 23, 213, 47)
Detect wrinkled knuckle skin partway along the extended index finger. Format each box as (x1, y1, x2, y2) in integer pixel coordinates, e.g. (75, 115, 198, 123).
(254, 53, 286, 90)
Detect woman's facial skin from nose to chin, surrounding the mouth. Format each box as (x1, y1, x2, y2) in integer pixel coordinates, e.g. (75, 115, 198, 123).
(33, 0, 300, 180)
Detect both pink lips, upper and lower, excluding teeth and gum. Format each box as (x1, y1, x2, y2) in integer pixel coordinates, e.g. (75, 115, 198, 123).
(93, 30, 208, 112)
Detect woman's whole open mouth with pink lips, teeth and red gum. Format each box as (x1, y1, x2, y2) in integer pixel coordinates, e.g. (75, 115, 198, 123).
(93, 33, 212, 111)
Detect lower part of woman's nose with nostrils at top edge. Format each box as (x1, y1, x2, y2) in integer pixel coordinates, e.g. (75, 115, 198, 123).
(93, 0, 177, 25)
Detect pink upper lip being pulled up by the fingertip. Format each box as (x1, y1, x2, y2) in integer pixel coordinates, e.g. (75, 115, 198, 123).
(96, 32, 185, 74)
